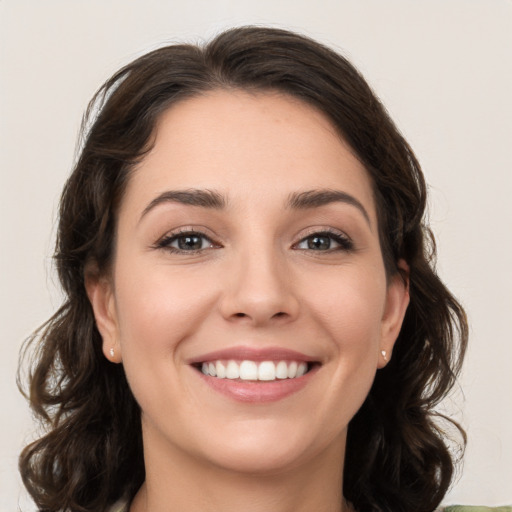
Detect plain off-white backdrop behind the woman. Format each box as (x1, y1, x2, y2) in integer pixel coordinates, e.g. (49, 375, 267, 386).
(0, 0, 512, 512)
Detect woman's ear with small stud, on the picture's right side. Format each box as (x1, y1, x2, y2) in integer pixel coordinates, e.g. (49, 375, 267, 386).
(378, 260, 409, 368)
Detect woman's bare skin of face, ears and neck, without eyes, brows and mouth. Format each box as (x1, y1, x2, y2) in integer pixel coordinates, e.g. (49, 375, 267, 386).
(86, 91, 409, 512)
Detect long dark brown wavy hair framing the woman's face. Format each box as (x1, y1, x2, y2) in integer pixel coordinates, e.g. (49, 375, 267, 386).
(19, 27, 467, 512)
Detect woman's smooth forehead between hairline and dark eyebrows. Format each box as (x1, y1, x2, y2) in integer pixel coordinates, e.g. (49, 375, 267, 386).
(123, 91, 374, 220)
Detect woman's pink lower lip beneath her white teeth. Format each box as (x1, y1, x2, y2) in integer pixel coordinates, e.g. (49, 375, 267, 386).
(196, 367, 318, 403)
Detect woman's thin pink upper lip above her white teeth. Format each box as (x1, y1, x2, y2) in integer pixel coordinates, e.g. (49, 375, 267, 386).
(188, 346, 319, 364)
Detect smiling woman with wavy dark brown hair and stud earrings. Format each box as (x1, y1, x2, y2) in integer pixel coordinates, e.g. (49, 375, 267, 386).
(20, 27, 467, 512)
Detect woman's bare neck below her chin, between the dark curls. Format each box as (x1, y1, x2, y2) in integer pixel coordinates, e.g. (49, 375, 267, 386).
(130, 424, 351, 512)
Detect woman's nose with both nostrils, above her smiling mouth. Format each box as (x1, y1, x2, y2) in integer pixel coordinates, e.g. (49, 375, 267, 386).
(220, 246, 300, 326)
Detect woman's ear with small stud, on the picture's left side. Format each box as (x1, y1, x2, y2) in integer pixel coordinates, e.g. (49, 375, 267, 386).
(85, 269, 122, 363)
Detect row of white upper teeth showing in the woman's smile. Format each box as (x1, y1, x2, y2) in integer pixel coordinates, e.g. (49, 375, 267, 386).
(201, 360, 308, 381)
